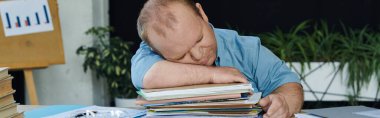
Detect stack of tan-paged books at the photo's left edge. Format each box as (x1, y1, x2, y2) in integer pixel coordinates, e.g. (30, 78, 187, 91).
(0, 67, 23, 118)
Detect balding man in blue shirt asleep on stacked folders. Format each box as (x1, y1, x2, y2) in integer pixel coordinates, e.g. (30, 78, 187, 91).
(132, 0, 303, 118)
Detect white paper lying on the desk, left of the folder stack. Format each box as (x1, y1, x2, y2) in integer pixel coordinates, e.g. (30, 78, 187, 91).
(45, 106, 146, 118)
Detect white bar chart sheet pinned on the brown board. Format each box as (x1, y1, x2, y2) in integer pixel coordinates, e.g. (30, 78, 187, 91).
(0, 0, 54, 37)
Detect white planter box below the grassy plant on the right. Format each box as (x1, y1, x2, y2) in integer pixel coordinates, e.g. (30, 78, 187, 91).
(288, 62, 378, 101)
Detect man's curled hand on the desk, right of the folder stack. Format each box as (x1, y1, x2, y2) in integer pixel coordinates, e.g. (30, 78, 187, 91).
(259, 93, 292, 118)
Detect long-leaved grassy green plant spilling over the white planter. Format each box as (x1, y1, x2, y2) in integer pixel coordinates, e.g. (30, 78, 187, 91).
(260, 21, 380, 105)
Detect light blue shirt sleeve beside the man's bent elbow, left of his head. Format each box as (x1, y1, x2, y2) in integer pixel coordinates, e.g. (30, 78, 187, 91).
(131, 41, 163, 89)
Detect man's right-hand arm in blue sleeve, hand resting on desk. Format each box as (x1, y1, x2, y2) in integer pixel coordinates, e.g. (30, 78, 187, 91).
(256, 42, 304, 118)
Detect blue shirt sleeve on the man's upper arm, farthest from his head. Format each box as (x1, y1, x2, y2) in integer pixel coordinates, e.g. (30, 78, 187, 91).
(255, 43, 300, 97)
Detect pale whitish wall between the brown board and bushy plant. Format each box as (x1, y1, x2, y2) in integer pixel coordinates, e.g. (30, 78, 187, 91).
(33, 0, 108, 105)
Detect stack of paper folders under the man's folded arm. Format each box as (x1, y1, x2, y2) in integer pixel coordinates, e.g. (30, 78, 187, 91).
(136, 83, 261, 117)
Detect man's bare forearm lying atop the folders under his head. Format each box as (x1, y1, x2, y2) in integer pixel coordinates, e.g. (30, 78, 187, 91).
(143, 61, 248, 88)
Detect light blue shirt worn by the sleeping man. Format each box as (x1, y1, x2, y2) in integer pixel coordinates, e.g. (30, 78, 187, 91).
(132, 28, 300, 97)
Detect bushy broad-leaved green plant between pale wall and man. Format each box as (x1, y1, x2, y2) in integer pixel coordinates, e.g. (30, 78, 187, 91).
(76, 27, 137, 105)
